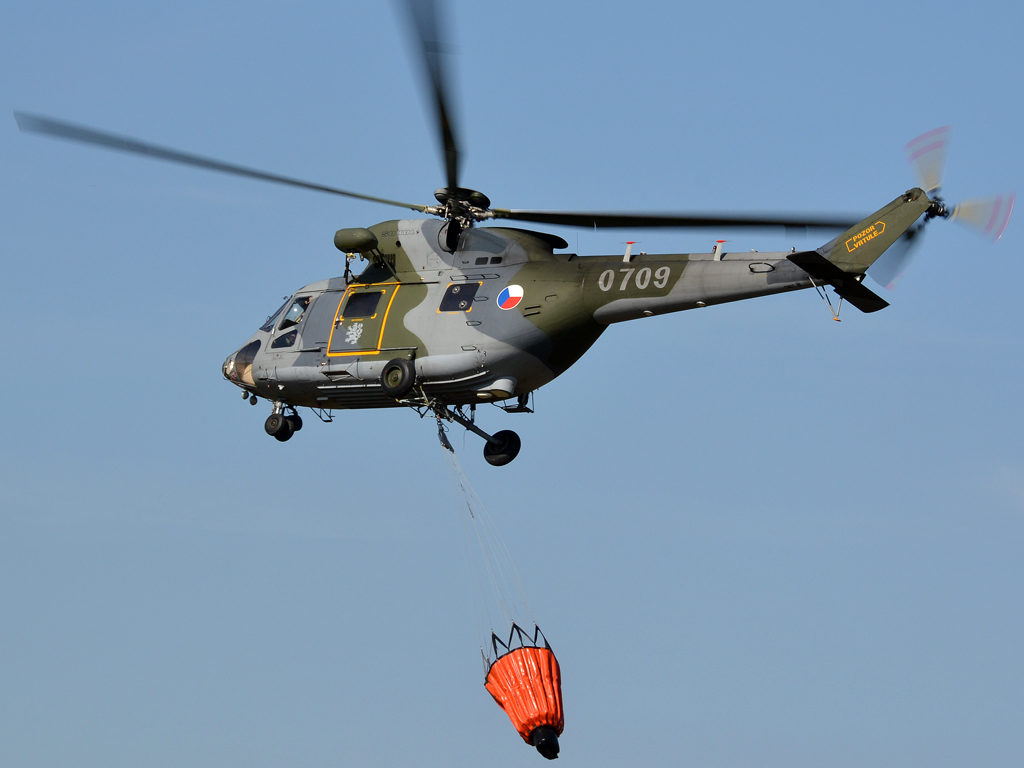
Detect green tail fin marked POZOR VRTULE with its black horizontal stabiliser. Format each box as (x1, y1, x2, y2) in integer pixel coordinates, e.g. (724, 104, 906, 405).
(787, 188, 932, 312)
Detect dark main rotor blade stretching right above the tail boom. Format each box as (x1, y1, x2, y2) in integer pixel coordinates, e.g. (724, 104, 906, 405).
(492, 208, 863, 229)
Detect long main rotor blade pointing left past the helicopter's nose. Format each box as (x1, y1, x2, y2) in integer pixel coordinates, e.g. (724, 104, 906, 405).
(14, 112, 426, 213)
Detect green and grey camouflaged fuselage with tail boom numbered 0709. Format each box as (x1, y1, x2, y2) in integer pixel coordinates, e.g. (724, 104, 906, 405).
(223, 189, 932, 410)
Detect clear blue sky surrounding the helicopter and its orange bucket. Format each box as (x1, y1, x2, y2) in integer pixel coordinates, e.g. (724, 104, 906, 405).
(0, 0, 1024, 768)
